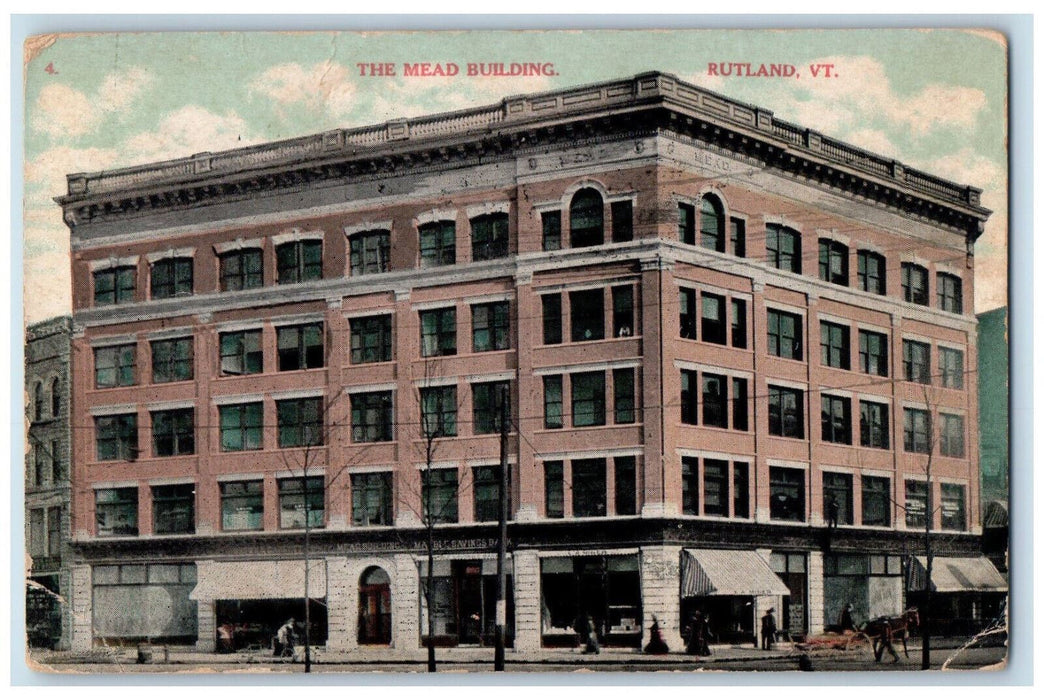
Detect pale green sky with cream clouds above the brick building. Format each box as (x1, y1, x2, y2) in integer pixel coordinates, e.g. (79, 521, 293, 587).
(18, 29, 1007, 323)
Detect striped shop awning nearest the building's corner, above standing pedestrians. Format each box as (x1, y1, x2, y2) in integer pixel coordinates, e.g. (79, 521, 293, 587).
(682, 550, 790, 598)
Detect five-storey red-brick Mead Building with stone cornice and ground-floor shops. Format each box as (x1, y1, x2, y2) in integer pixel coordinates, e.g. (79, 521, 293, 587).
(58, 73, 989, 651)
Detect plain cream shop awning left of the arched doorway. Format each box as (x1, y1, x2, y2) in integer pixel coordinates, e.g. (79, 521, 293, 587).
(189, 559, 326, 601)
